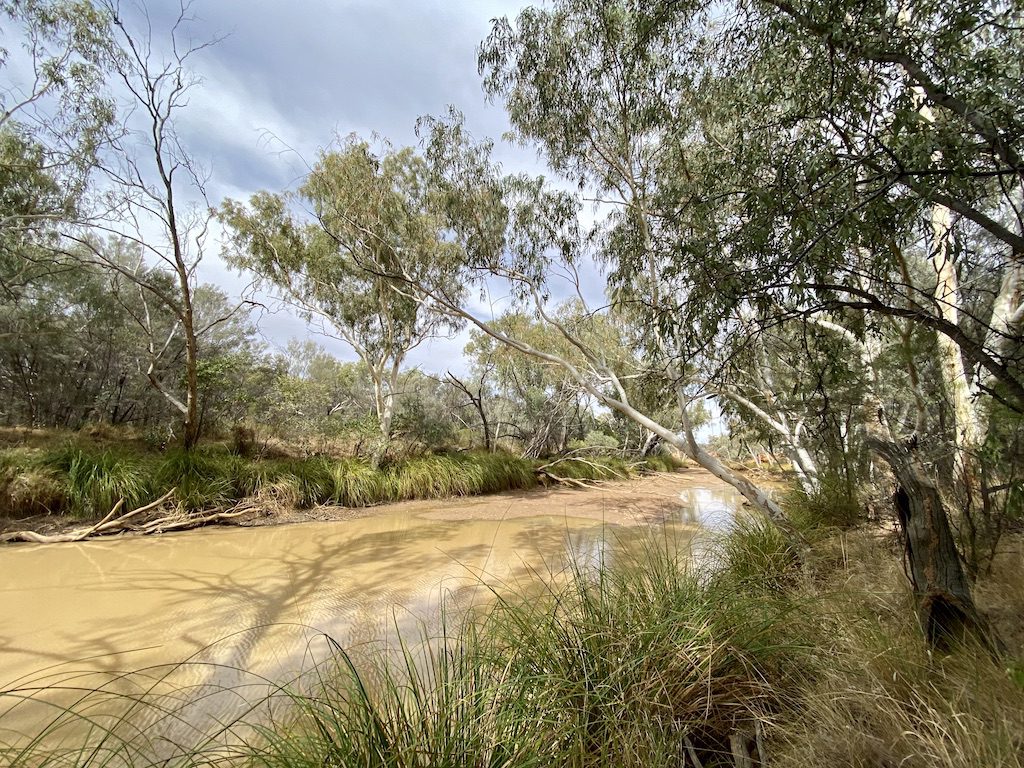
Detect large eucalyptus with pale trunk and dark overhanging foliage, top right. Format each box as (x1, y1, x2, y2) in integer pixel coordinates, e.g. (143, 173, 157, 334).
(703, 2, 1024, 462)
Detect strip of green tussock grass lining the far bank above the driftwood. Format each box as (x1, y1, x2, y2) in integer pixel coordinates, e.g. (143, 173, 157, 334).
(0, 441, 676, 518)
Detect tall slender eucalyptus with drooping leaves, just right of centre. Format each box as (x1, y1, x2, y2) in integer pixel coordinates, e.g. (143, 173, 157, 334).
(471, 0, 781, 517)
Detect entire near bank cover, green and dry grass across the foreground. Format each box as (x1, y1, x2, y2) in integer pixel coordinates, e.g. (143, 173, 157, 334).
(5, 518, 1024, 768)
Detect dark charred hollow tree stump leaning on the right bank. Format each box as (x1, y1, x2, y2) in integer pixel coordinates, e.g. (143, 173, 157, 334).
(868, 437, 987, 648)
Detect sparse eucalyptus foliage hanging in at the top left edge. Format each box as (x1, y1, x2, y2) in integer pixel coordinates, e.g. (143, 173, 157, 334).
(0, 0, 115, 268)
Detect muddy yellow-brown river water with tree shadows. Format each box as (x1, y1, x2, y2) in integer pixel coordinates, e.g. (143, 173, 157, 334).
(0, 472, 737, 742)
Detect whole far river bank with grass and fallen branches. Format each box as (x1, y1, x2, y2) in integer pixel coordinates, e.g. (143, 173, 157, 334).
(0, 423, 753, 543)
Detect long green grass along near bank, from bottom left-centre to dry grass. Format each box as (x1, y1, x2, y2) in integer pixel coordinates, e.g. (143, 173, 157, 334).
(245, 546, 798, 766)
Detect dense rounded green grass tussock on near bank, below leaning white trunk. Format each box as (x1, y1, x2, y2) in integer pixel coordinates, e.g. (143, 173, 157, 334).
(479, 546, 801, 766)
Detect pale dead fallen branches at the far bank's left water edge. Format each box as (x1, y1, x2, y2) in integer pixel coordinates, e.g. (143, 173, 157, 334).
(0, 488, 256, 544)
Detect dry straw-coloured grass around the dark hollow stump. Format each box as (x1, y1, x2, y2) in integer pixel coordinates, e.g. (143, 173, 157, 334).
(769, 530, 1024, 768)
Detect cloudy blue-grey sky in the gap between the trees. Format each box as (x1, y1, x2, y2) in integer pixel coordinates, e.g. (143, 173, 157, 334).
(146, 0, 543, 372)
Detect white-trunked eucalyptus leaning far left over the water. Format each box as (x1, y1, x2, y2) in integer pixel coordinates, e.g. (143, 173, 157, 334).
(313, 113, 784, 523)
